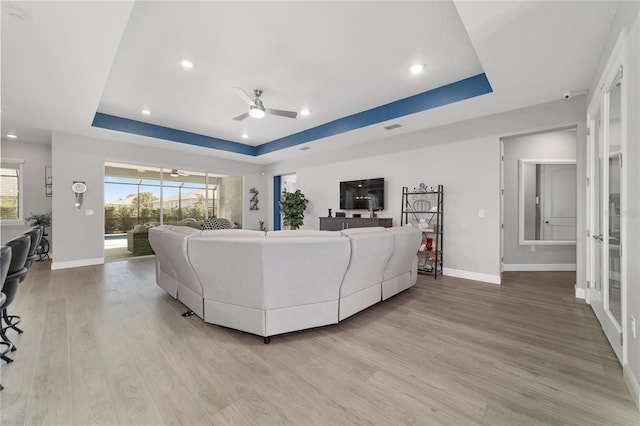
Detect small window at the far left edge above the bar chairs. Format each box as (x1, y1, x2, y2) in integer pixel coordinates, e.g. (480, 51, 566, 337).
(0, 159, 23, 224)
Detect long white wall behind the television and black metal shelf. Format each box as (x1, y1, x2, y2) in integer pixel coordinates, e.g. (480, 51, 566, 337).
(265, 95, 585, 283)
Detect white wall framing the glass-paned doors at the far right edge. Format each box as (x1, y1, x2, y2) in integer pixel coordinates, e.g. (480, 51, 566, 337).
(590, 2, 640, 407)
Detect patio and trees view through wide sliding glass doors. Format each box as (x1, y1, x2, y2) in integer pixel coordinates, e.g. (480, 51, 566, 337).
(104, 163, 243, 257)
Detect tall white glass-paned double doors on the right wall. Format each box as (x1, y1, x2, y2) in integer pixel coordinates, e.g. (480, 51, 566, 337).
(588, 64, 624, 362)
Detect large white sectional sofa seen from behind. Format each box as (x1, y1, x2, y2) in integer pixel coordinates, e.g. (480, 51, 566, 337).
(149, 225, 422, 343)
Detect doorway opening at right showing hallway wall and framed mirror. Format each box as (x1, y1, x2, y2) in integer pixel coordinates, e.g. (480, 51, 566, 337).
(501, 126, 577, 271)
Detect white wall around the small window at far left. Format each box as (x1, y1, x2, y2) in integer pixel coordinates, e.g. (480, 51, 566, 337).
(0, 139, 55, 245)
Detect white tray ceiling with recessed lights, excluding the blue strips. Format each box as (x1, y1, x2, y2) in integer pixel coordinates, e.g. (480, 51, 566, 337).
(1, 1, 618, 164)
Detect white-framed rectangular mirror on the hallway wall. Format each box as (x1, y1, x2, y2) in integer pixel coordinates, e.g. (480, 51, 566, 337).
(518, 159, 576, 245)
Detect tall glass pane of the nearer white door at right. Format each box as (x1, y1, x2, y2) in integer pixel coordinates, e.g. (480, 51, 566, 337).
(607, 80, 622, 324)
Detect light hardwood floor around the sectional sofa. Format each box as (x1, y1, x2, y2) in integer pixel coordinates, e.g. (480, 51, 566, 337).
(0, 258, 640, 426)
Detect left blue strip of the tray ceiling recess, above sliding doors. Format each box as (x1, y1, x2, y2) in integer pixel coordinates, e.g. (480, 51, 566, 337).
(92, 112, 256, 156)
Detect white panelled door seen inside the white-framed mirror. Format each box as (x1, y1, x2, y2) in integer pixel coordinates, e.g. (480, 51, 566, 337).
(540, 164, 576, 241)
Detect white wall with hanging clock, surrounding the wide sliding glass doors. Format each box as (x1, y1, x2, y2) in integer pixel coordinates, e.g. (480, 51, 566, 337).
(52, 133, 266, 269)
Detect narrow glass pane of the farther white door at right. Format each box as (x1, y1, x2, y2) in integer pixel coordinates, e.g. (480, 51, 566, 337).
(592, 110, 604, 293)
